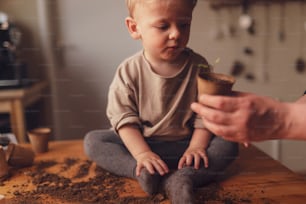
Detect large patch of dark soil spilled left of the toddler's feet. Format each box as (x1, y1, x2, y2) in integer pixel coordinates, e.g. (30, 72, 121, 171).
(5, 158, 165, 204)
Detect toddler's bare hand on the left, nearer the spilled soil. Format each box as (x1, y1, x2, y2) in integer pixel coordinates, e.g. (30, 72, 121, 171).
(135, 151, 169, 176)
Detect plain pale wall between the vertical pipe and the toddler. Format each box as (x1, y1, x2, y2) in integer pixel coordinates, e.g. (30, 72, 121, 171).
(45, 0, 140, 139)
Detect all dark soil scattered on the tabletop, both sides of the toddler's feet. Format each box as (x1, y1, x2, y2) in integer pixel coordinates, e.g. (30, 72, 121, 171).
(1, 158, 270, 204)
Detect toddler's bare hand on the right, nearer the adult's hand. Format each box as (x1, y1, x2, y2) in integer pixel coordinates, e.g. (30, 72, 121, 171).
(178, 147, 208, 169)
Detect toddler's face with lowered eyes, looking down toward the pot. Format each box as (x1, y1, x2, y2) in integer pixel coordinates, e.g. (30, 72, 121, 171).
(134, 0, 193, 62)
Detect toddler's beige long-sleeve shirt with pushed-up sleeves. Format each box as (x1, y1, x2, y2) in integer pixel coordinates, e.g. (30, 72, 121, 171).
(107, 49, 208, 140)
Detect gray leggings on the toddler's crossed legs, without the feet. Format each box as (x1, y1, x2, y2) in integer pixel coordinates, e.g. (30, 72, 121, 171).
(84, 130, 238, 186)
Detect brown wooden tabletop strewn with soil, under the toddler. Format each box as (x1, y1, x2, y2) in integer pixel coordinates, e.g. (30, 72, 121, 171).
(0, 140, 306, 204)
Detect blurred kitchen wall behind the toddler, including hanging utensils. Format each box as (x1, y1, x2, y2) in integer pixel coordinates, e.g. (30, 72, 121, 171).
(0, 0, 306, 173)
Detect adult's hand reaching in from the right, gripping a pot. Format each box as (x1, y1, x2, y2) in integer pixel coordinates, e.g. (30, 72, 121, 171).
(191, 92, 289, 142)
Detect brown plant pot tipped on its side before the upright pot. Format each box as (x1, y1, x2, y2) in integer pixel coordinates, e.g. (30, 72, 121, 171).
(6, 143, 35, 167)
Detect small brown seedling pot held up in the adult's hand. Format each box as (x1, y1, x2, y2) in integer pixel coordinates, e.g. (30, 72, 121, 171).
(197, 73, 236, 95)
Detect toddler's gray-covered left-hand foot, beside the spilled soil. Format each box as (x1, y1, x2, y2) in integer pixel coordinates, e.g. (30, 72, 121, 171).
(135, 169, 161, 195)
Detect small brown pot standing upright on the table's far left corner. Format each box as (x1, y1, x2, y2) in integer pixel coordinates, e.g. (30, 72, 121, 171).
(28, 128, 51, 154)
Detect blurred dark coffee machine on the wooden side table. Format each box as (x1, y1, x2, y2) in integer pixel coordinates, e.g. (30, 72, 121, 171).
(0, 11, 29, 89)
